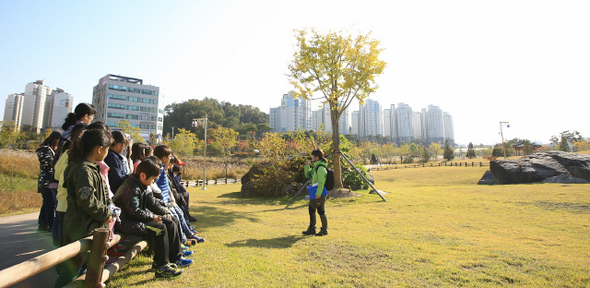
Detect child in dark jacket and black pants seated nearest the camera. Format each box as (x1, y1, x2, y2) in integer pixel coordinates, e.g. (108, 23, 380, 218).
(113, 157, 193, 278)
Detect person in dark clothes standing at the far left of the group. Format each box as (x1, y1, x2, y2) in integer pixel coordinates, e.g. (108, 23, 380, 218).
(36, 131, 61, 233)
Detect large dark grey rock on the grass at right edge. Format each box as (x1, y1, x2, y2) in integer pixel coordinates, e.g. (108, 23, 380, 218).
(490, 151, 590, 184)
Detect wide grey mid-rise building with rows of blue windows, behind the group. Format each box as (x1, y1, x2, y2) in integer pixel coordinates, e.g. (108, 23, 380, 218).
(92, 74, 164, 139)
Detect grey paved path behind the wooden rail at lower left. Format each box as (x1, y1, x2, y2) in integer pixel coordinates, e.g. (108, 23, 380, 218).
(0, 212, 57, 288)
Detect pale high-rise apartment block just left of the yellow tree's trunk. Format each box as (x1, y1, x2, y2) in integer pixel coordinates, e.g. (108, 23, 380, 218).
(268, 91, 312, 132)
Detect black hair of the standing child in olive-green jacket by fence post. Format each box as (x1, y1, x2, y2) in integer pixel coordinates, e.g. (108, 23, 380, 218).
(68, 129, 113, 164)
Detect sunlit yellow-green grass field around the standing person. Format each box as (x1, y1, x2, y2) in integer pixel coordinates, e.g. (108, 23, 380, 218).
(110, 167, 590, 288)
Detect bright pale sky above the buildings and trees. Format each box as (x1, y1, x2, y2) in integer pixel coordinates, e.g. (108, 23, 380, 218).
(0, 0, 590, 145)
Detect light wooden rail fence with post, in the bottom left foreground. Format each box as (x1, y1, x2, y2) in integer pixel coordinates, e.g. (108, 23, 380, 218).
(0, 228, 147, 288)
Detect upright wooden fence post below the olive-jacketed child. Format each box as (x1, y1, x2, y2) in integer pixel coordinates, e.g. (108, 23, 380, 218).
(84, 228, 111, 288)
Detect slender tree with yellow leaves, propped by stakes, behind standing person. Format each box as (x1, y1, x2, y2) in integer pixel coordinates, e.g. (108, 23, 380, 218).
(289, 30, 385, 188)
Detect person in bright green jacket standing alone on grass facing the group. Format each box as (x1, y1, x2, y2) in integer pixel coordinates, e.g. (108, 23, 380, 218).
(303, 149, 328, 236)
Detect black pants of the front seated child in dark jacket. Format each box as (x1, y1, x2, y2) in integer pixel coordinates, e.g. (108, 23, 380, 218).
(145, 217, 182, 267)
